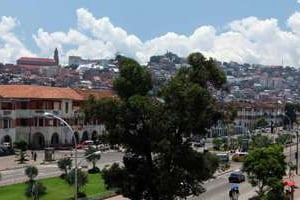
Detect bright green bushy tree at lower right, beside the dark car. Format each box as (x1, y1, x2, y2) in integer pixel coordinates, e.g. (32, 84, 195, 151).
(243, 145, 287, 197)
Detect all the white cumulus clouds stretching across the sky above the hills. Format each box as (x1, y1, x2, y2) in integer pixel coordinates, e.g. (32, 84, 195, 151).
(4, 8, 300, 66)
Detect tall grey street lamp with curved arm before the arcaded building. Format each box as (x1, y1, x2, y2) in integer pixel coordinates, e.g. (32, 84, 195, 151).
(44, 112, 78, 200)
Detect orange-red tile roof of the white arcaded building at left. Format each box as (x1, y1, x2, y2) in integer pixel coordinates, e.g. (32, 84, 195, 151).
(0, 85, 84, 100)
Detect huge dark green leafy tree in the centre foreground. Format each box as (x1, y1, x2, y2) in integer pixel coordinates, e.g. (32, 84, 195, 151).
(85, 53, 226, 200)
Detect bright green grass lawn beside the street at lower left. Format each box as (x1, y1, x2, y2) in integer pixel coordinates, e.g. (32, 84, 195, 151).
(0, 174, 108, 200)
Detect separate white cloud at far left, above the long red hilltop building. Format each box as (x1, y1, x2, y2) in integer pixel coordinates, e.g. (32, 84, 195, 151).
(0, 16, 33, 63)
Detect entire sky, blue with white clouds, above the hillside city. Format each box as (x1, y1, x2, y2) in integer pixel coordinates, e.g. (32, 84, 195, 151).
(0, 0, 300, 65)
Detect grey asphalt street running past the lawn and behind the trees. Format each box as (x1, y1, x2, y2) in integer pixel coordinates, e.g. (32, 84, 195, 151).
(0, 143, 296, 200)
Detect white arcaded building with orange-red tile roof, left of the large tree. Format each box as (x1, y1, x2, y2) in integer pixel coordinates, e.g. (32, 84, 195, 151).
(0, 85, 112, 149)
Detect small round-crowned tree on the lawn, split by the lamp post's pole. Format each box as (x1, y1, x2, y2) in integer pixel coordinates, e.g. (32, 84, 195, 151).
(67, 169, 88, 197)
